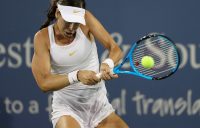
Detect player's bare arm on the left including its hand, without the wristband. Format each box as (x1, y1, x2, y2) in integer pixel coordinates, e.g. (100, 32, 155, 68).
(32, 30, 99, 92)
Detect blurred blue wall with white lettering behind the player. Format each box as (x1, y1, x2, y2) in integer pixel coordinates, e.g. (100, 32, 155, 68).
(0, 0, 200, 128)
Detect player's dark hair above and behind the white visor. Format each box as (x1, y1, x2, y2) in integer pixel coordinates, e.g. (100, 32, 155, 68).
(40, 0, 86, 29)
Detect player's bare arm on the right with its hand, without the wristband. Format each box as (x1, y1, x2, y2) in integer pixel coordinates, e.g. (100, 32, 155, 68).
(85, 11, 123, 80)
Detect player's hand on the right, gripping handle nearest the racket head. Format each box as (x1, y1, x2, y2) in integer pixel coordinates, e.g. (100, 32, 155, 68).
(100, 63, 118, 80)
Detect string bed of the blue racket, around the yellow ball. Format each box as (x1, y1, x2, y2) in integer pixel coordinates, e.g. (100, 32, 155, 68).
(132, 36, 179, 78)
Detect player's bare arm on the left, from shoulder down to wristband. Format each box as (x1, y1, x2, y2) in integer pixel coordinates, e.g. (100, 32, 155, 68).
(32, 29, 69, 92)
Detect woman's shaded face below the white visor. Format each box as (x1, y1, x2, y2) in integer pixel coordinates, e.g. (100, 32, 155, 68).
(57, 12, 80, 38)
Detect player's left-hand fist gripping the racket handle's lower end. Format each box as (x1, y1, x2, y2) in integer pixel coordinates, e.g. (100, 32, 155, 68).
(77, 70, 101, 85)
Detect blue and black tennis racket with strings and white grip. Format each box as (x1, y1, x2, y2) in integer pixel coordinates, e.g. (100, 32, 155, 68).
(97, 33, 180, 80)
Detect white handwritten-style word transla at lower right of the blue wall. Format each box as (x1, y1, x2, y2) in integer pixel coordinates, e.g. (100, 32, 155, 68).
(132, 90, 200, 117)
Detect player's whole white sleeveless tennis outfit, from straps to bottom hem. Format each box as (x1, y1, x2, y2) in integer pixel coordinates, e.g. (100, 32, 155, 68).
(48, 25, 114, 128)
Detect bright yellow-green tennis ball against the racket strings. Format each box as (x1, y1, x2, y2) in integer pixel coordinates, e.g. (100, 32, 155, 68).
(141, 56, 155, 68)
